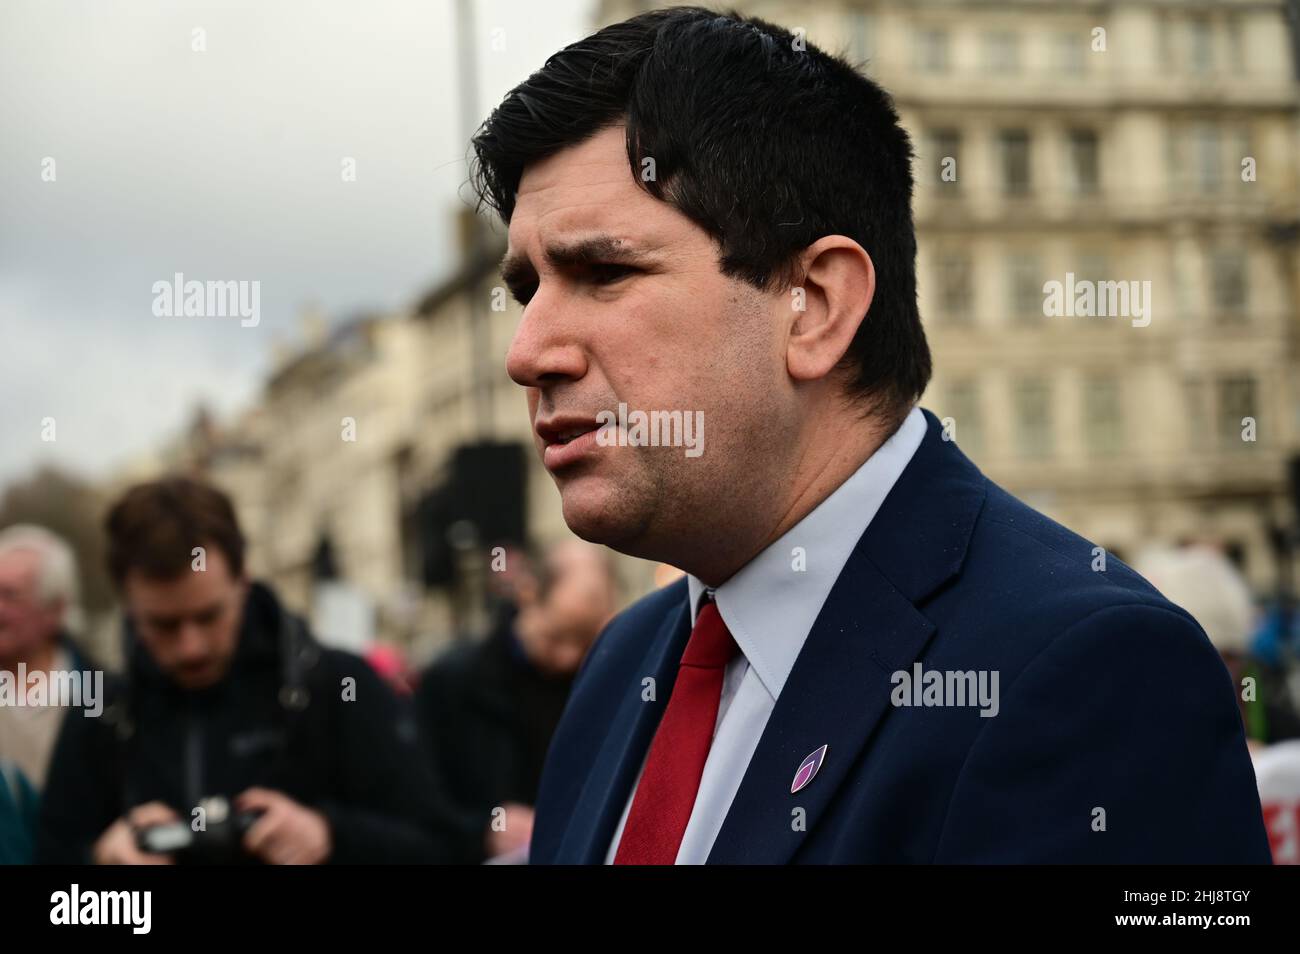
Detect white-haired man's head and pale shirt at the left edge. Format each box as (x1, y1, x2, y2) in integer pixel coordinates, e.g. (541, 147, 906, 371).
(0, 525, 86, 789)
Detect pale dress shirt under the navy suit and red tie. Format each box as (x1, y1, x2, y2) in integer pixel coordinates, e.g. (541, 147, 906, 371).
(605, 408, 926, 864)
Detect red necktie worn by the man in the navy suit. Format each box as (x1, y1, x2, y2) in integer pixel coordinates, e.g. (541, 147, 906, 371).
(614, 600, 737, 864)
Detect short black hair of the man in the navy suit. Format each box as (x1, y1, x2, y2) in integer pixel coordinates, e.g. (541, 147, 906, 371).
(471, 6, 931, 419)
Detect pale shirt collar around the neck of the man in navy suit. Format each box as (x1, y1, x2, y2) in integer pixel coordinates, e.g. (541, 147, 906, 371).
(686, 407, 926, 699)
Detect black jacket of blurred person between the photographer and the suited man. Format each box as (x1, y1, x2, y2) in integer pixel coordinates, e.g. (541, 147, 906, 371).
(415, 612, 573, 864)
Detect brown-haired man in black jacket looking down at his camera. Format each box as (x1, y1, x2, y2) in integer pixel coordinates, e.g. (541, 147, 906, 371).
(36, 478, 446, 864)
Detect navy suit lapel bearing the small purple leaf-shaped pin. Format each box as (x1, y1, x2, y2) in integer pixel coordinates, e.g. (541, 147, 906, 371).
(709, 412, 985, 864)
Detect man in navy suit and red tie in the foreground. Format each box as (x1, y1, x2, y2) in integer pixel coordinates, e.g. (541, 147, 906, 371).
(473, 8, 1269, 864)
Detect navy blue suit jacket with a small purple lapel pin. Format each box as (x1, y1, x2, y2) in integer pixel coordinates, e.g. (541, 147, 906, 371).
(530, 412, 1270, 864)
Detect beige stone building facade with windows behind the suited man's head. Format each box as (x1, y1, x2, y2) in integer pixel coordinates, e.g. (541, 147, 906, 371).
(598, 0, 1300, 591)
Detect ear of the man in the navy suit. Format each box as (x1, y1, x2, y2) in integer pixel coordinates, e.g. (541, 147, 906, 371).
(785, 235, 876, 381)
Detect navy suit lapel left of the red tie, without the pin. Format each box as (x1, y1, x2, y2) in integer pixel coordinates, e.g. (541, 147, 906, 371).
(556, 582, 690, 864)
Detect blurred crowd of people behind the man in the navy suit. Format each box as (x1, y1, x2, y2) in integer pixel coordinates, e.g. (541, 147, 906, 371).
(0, 478, 1300, 864)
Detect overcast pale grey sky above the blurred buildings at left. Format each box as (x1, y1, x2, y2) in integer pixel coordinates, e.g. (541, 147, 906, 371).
(0, 0, 593, 485)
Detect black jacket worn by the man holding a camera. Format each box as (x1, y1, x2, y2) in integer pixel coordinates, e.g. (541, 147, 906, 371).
(36, 584, 450, 863)
